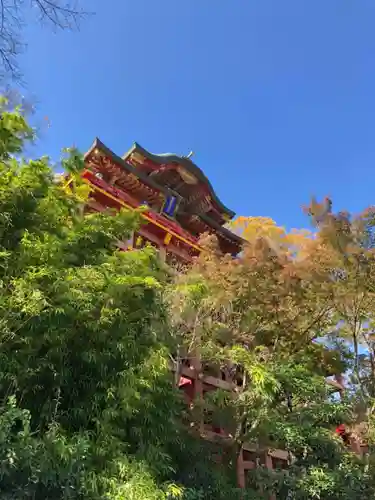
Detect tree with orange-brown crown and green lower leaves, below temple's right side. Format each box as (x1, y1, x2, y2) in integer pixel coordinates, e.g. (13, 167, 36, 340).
(170, 229, 374, 500)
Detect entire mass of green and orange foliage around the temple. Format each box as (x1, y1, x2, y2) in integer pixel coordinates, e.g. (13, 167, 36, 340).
(0, 99, 375, 500)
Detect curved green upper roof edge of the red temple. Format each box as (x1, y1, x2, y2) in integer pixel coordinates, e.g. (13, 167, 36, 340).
(128, 142, 236, 219)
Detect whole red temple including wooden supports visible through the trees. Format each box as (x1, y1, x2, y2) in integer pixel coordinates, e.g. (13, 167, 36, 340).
(82, 139, 356, 487)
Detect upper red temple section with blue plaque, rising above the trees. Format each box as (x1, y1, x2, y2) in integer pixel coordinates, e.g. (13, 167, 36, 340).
(83, 139, 242, 263)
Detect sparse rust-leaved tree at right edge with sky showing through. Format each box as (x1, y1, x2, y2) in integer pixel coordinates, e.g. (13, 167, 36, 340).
(307, 197, 375, 440)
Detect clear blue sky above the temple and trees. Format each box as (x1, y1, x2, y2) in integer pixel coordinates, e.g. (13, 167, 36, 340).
(18, 0, 375, 227)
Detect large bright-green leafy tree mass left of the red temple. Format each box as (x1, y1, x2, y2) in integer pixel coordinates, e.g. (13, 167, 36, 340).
(0, 98, 184, 499)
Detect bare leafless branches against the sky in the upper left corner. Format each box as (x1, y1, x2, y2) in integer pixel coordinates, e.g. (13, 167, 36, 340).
(0, 0, 87, 80)
